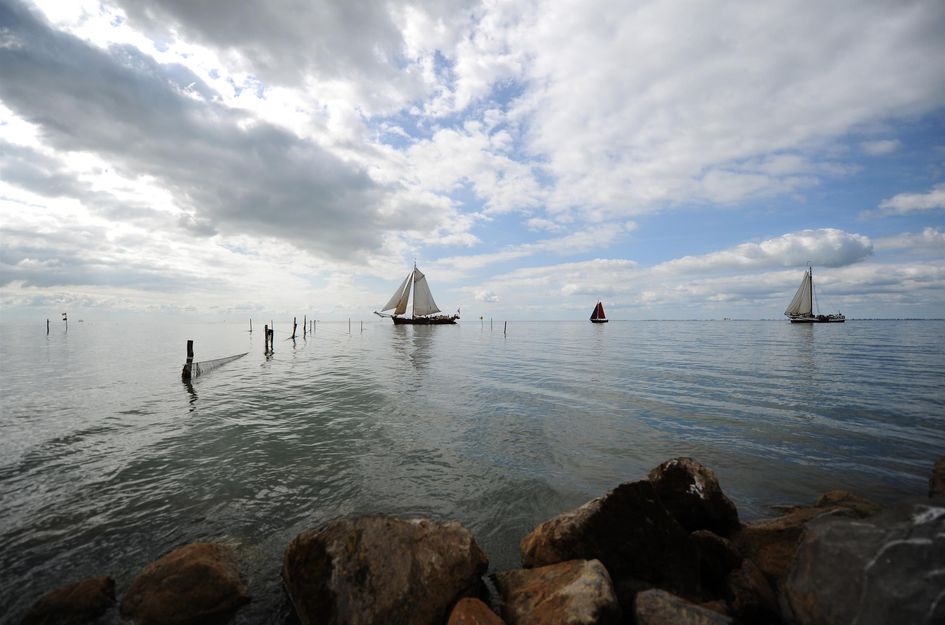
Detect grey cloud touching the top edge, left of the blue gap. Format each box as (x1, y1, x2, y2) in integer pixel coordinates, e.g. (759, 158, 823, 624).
(116, 0, 473, 101)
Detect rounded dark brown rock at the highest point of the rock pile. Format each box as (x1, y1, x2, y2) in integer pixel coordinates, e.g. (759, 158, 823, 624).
(648, 458, 740, 537)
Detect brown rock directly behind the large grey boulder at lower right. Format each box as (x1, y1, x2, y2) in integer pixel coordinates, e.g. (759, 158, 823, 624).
(735, 491, 880, 583)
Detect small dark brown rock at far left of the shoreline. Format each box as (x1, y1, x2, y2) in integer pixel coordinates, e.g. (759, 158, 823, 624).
(20, 577, 115, 625)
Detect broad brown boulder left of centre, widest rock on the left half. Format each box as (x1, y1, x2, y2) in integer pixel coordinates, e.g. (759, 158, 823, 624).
(282, 516, 489, 625)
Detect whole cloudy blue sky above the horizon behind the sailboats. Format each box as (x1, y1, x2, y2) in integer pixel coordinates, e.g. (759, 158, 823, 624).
(0, 0, 945, 321)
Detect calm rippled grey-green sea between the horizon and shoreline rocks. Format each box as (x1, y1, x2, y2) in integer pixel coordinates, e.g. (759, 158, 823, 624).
(0, 320, 945, 623)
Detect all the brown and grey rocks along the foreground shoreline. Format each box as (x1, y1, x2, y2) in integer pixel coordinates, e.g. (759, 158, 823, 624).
(21, 457, 945, 625)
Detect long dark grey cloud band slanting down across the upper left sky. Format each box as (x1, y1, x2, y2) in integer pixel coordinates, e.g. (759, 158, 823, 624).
(0, 4, 398, 258)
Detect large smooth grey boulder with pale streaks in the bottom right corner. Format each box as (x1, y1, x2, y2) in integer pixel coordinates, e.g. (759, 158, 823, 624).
(784, 500, 945, 625)
